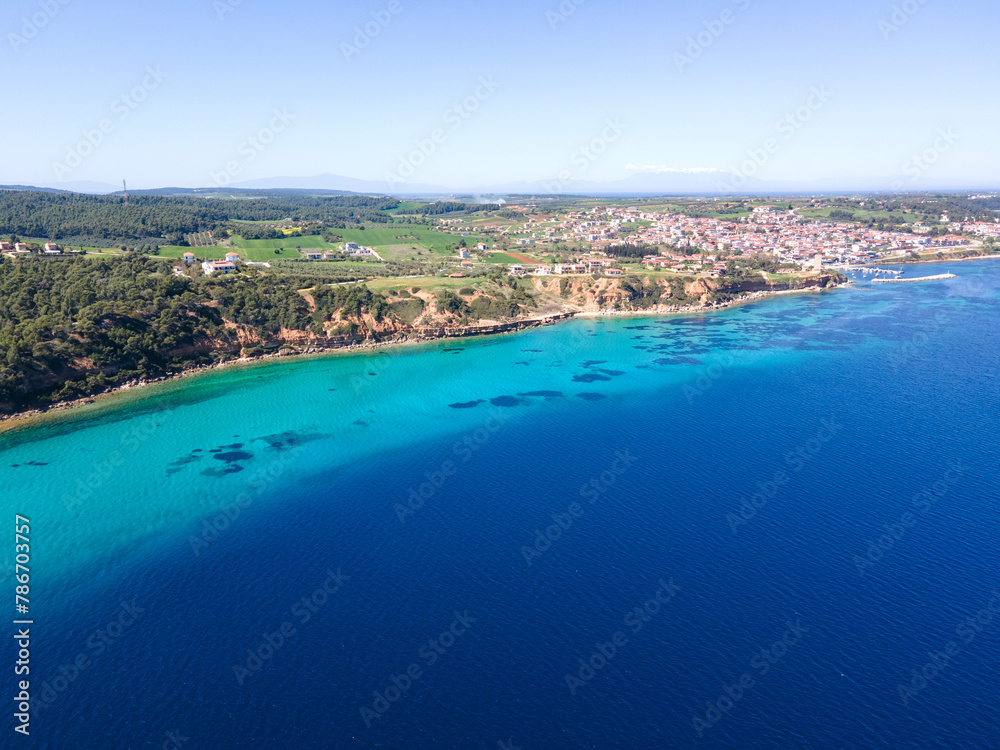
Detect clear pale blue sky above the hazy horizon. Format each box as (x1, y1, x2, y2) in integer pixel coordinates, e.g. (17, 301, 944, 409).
(0, 0, 1000, 187)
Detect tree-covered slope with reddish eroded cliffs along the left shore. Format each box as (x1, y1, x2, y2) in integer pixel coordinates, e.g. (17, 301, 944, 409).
(0, 253, 548, 413)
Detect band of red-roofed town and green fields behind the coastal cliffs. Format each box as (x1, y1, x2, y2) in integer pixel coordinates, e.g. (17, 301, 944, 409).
(0, 195, 1000, 281)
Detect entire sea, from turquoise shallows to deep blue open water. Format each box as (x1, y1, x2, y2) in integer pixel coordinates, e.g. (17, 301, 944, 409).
(0, 260, 1000, 750)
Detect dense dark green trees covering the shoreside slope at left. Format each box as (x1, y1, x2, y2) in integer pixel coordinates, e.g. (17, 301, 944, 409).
(0, 253, 392, 411)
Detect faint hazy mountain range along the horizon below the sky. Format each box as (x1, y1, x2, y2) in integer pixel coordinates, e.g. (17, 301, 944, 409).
(7, 171, 1000, 197)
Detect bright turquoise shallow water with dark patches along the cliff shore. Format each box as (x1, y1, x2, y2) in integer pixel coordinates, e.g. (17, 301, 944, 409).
(2, 288, 844, 592)
